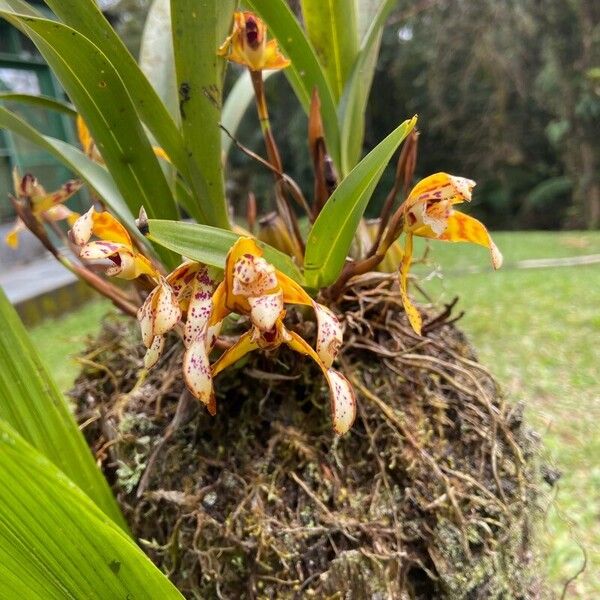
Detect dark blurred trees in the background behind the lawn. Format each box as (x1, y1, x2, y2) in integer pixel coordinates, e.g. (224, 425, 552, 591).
(105, 0, 600, 229)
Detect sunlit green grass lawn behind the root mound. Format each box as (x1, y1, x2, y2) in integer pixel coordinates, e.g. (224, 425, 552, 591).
(25, 232, 600, 599)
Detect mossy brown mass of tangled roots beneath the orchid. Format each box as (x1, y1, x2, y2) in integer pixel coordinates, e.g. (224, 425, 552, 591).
(72, 276, 546, 600)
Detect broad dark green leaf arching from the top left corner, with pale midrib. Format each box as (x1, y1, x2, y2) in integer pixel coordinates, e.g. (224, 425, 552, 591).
(0, 10, 178, 266)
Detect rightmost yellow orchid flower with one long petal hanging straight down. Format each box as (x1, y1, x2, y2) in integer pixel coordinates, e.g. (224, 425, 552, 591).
(400, 173, 502, 335)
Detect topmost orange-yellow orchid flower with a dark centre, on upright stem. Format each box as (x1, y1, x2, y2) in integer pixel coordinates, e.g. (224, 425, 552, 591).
(218, 12, 291, 71)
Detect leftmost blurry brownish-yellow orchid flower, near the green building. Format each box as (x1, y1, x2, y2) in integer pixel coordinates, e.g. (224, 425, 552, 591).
(5, 168, 83, 248)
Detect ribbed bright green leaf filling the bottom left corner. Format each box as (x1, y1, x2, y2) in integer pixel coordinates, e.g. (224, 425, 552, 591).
(0, 421, 183, 600)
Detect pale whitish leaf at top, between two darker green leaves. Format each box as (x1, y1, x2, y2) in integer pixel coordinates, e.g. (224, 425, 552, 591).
(139, 0, 179, 122)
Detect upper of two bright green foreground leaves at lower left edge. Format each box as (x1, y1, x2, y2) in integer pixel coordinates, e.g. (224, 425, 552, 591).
(0, 288, 126, 528)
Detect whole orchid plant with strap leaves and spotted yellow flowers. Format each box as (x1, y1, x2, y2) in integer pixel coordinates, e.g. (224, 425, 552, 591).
(0, 0, 502, 434)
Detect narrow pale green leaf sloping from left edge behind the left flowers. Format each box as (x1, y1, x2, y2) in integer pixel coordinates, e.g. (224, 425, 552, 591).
(0, 106, 140, 236)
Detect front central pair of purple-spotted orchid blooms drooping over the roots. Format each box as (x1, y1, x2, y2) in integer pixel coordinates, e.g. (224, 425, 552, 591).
(138, 237, 356, 434)
